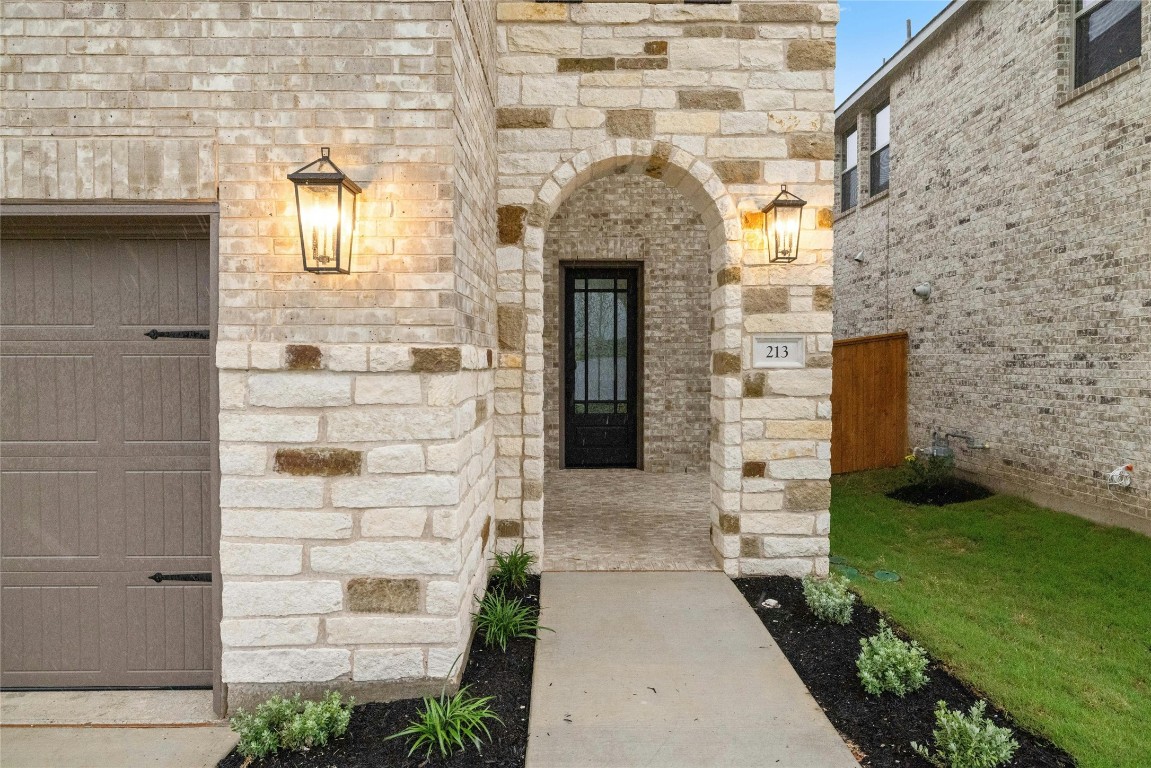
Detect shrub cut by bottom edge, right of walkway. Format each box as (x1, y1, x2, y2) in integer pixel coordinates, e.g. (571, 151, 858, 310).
(912, 701, 1019, 768)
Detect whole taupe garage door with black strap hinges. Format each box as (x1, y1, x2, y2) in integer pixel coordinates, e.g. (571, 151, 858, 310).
(0, 218, 213, 687)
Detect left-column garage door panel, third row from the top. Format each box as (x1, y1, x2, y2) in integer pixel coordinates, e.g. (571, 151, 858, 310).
(0, 470, 101, 559)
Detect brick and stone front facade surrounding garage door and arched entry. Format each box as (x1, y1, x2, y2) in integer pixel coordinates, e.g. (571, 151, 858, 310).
(2, 0, 837, 706)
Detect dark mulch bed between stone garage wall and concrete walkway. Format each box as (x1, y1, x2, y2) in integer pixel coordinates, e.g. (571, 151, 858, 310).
(218, 576, 540, 768)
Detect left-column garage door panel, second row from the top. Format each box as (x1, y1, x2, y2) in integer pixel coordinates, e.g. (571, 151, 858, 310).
(0, 350, 96, 442)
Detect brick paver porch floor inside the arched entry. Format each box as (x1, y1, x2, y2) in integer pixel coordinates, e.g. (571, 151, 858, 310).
(543, 470, 719, 571)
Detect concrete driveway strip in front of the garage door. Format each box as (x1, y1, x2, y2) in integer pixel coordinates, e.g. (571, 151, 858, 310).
(0, 691, 237, 768)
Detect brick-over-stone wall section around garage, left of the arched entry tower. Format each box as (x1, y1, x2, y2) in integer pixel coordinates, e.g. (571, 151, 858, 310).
(0, 0, 496, 706)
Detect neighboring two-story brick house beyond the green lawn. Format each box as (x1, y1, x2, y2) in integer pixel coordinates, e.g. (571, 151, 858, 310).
(834, 0, 1151, 533)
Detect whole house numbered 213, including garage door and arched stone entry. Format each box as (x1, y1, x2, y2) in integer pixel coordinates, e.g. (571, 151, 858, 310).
(0, 0, 838, 709)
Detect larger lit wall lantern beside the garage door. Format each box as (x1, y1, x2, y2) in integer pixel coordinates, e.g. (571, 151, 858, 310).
(288, 146, 361, 274)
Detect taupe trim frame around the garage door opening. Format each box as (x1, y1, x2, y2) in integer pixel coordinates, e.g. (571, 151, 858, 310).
(0, 200, 228, 717)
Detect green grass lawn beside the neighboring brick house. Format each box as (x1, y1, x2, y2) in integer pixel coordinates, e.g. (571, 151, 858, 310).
(831, 470, 1151, 768)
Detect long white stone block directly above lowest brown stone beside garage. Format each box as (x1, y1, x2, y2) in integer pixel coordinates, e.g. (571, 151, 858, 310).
(310, 541, 459, 576)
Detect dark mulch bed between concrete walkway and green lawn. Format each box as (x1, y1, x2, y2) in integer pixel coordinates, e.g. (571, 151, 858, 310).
(735, 577, 1075, 768)
